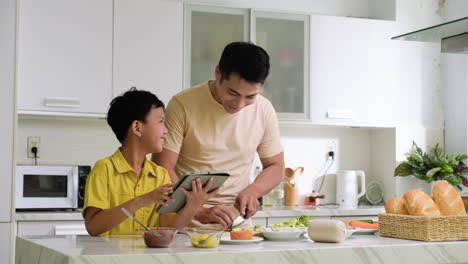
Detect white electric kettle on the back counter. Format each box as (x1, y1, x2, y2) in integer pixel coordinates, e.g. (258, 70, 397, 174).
(336, 170, 366, 208)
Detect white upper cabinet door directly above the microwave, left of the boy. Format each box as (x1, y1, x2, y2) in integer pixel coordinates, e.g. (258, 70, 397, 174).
(17, 0, 113, 114)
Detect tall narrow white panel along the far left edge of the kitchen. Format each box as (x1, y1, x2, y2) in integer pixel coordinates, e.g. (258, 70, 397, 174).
(0, 0, 16, 263)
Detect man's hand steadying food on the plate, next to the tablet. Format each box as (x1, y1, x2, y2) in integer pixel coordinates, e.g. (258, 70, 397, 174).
(195, 204, 236, 228)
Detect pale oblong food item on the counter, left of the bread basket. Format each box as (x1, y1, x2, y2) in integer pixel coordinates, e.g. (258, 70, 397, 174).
(308, 219, 346, 243)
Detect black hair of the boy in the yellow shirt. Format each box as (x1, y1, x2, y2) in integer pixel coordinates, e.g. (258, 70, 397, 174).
(107, 87, 164, 143)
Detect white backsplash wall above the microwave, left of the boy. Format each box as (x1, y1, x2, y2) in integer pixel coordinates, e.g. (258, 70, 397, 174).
(16, 118, 120, 166)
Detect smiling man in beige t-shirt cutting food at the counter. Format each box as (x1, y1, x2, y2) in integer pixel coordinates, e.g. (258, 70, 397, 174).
(153, 42, 284, 227)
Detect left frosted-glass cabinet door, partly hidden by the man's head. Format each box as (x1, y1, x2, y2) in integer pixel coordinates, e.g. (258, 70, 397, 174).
(184, 5, 249, 88)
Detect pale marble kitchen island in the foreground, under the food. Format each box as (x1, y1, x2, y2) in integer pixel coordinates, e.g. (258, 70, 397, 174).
(16, 234, 468, 264)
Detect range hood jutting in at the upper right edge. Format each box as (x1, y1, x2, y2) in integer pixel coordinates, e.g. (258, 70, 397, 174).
(392, 17, 468, 54)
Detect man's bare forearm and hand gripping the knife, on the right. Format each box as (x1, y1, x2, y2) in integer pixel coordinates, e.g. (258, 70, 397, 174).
(234, 152, 284, 218)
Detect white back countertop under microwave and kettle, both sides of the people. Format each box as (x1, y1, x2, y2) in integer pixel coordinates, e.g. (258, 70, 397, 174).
(15, 205, 385, 221)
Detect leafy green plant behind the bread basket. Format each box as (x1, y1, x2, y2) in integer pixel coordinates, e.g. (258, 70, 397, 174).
(395, 141, 468, 189)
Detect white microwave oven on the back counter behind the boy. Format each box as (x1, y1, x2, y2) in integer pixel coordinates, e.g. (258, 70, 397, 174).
(15, 165, 91, 209)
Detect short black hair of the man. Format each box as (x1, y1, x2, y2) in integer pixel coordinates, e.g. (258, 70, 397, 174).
(218, 41, 270, 83)
